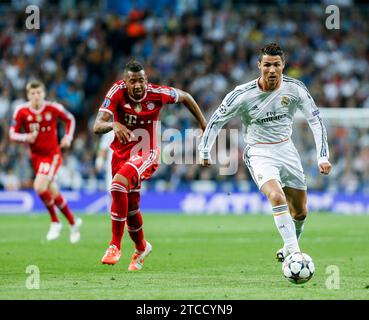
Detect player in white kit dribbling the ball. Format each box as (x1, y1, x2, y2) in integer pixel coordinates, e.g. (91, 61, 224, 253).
(199, 43, 332, 262)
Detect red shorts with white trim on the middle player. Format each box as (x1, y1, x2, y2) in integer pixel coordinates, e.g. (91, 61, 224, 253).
(111, 149, 160, 192)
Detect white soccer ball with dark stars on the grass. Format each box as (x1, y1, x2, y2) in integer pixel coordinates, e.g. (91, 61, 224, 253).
(282, 252, 315, 284)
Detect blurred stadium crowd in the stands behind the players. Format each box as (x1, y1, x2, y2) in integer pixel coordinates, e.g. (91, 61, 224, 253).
(0, 0, 369, 192)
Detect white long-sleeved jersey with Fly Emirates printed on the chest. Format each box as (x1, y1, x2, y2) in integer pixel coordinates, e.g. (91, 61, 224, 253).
(199, 75, 329, 163)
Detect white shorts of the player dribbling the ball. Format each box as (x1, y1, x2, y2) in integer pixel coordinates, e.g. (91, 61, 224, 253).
(243, 139, 307, 190)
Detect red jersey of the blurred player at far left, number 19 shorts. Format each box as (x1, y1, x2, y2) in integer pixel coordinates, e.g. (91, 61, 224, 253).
(9, 101, 75, 156)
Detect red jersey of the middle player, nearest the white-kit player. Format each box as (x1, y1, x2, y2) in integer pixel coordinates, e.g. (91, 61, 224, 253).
(99, 80, 179, 158)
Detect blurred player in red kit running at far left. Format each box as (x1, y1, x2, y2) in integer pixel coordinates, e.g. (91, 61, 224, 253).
(9, 80, 82, 243)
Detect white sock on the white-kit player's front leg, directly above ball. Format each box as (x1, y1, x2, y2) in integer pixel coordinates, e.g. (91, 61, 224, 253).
(273, 204, 300, 254)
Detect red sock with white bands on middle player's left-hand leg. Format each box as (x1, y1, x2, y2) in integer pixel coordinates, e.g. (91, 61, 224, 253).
(110, 182, 128, 250)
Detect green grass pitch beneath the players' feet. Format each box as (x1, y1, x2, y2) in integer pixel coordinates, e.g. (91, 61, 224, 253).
(0, 213, 369, 300)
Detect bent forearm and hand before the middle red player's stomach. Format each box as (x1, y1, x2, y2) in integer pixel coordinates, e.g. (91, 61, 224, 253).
(93, 111, 135, 143)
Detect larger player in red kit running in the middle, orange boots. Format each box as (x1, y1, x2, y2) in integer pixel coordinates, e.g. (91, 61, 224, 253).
(94, 60, 206, 271)
